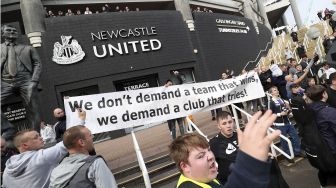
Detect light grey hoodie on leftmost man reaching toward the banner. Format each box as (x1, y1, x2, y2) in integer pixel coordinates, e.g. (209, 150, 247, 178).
(3, 142, 67, 188)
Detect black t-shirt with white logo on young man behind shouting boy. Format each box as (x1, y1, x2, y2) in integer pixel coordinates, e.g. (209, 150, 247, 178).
(210, 132, 238, 185)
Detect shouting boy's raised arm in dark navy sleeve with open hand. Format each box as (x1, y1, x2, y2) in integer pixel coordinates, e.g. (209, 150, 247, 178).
(225, 110, 280, 188)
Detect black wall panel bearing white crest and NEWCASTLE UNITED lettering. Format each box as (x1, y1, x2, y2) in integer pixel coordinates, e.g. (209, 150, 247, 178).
(43, 11, 195, 84)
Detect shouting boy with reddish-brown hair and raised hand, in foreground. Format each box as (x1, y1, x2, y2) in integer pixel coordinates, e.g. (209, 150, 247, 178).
(169, 110, 280, 188)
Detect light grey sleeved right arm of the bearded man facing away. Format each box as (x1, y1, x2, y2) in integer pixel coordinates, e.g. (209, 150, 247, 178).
(87, 158, 118, 188)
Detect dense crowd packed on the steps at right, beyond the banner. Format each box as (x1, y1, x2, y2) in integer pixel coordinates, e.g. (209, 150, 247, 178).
(259, 37, 336, 186)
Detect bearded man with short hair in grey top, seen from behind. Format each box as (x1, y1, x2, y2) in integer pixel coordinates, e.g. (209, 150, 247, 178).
(49, 125, 117, 188)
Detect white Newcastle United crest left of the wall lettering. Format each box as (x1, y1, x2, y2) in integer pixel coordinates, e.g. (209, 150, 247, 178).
(52, 35, 85, 65)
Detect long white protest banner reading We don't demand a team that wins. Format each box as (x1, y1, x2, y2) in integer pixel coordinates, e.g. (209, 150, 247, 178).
(64, 71, 265, 133)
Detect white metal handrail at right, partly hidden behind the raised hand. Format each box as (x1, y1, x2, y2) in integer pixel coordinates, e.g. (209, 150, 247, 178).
(231, 104, 294, 159)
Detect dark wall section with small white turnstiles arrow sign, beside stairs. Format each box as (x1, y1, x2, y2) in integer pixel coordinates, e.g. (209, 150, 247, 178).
(194, 12, 271, 80)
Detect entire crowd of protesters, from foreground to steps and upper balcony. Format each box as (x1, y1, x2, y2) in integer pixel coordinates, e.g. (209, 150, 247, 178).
(1, 4, 336, 188)
